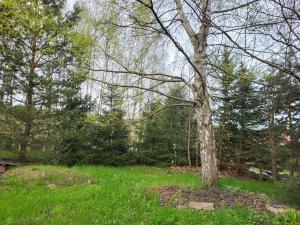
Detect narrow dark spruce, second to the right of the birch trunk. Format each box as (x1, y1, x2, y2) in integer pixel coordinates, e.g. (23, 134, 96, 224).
(231, 65, 264, 173)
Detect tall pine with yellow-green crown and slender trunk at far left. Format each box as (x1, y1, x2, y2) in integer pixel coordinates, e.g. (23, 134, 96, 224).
(0, 0, 89, 159)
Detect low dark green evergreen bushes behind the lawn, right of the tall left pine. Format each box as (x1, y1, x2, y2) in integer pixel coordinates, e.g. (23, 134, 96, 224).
(56, 111, 131, 166)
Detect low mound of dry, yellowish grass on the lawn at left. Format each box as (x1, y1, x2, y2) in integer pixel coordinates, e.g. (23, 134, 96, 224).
(1, 167, 93, 189)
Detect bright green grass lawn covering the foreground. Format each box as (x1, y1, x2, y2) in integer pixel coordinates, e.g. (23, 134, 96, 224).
(0, 165, 299, 225)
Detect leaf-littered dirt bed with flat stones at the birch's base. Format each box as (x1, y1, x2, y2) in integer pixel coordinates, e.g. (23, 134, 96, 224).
(156, 185, 290, 213)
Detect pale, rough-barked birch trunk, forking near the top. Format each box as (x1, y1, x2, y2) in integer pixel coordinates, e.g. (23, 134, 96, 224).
(175, 0, 218, 188)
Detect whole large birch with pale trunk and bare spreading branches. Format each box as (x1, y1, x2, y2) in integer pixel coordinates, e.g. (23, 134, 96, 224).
(78, 0, 299, 187)
